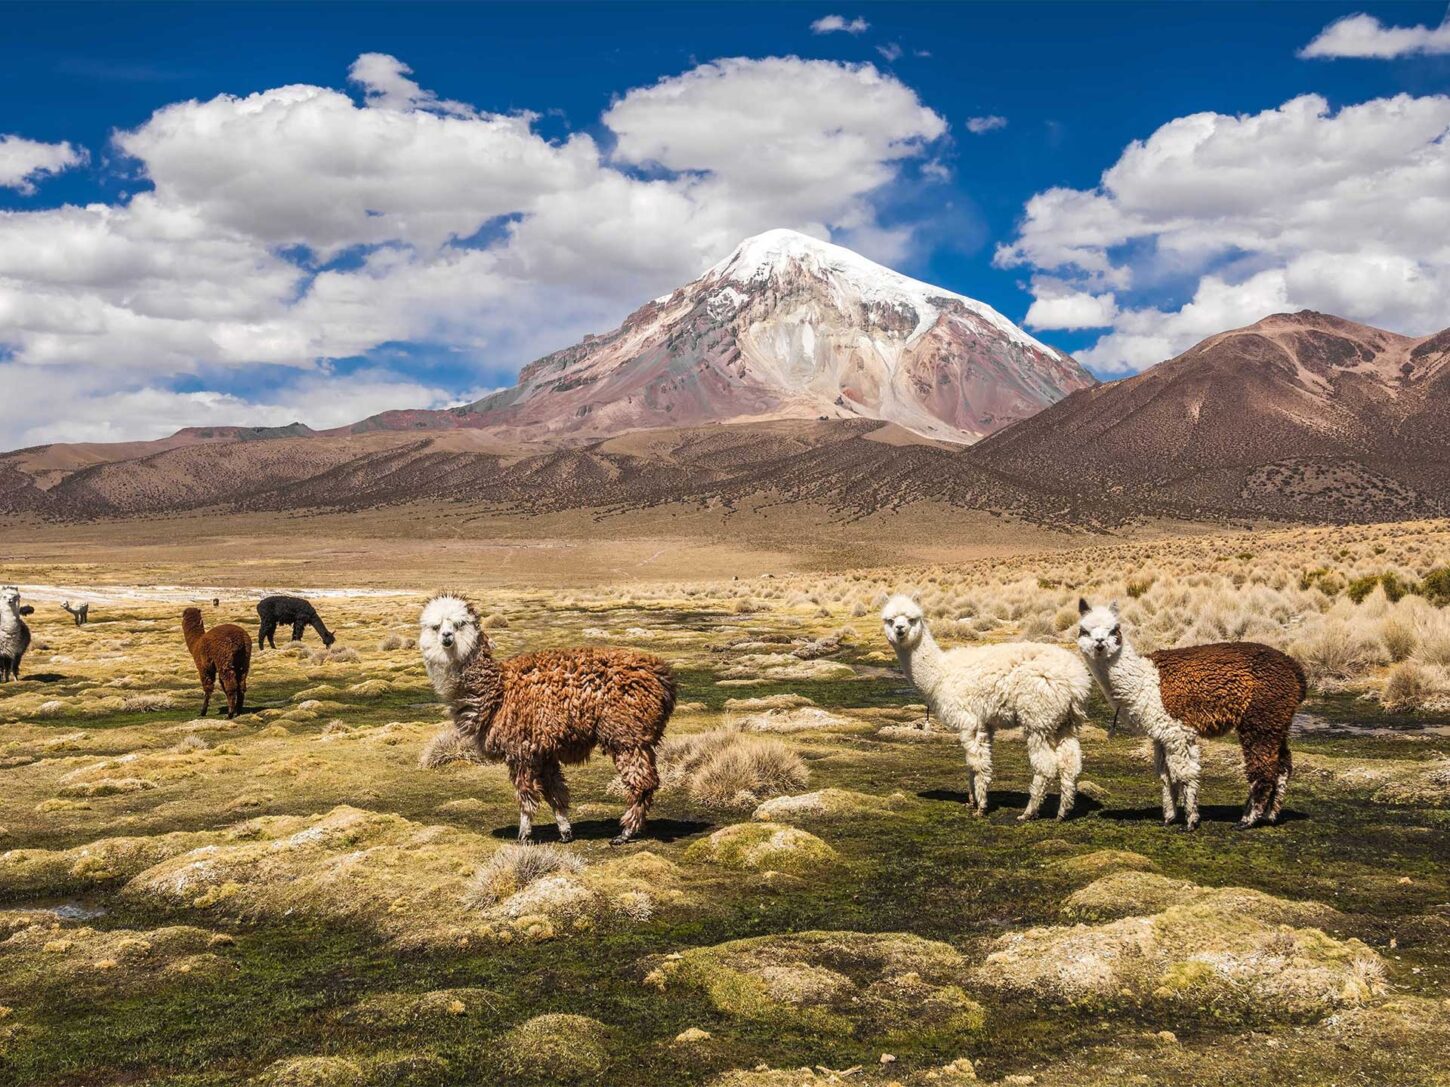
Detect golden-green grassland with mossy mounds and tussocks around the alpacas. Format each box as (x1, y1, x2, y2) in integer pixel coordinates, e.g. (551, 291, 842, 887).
(0, 522, 1450, 1087)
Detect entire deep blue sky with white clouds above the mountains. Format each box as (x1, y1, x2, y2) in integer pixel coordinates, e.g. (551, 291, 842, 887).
(0, 3, 1450, 445)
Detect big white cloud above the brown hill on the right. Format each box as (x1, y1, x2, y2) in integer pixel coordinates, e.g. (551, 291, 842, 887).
(996, 94, 1450, 371)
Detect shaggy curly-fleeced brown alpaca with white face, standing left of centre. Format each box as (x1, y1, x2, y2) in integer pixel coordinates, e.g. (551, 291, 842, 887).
(418, 596, 676, 845)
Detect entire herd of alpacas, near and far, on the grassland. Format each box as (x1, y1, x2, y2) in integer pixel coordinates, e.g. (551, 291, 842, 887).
(0, 586, 1306, 845)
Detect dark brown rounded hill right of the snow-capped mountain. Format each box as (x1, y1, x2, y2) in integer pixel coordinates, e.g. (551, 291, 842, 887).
(973, 312, 1450, 520)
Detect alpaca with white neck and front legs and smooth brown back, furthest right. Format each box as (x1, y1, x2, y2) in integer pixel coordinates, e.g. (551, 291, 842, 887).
(1077, 600, 1308, 830)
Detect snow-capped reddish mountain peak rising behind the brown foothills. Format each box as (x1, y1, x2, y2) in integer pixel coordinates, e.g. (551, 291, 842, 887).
(352, 230, 1095, 443)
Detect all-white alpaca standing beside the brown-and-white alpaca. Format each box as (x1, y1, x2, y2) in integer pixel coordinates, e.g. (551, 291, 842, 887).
(882, 596, 1092, 820)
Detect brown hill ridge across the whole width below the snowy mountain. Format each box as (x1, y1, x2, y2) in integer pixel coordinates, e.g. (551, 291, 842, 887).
(0, 312, 1450, 525)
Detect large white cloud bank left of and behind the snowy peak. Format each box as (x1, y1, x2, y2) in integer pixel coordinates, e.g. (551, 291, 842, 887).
(0, 54, 945, 446)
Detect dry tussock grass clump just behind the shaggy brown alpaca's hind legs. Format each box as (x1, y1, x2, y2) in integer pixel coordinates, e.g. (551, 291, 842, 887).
(660, 729, 811, 810)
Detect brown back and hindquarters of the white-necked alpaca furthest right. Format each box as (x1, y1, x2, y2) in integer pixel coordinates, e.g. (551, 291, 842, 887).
(1148, 642, 1309, 822)
